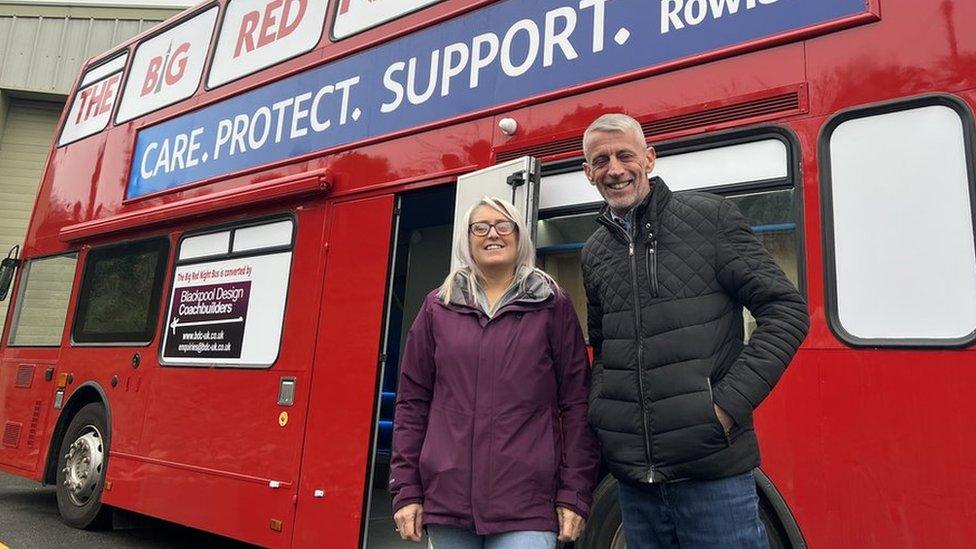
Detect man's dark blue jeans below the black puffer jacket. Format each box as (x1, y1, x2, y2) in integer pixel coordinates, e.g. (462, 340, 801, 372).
(620, 472, 769, 549)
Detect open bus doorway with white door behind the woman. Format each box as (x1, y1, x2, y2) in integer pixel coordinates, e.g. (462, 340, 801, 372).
(350, 158, 539, 548)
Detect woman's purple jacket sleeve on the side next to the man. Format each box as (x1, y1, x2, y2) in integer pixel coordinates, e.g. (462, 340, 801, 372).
(549, 289, 600, 519)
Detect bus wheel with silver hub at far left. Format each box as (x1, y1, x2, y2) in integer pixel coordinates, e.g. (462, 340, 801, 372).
(57, 403, 111, 529)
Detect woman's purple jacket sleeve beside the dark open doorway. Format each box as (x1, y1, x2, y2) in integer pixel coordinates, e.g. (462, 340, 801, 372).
(390, 295, 435, 512)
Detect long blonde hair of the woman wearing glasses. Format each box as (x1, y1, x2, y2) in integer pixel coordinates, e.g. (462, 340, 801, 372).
(437, 196, 552, 303)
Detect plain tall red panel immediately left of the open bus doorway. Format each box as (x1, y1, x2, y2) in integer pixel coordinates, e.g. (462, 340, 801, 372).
(293, 195, 393, 548)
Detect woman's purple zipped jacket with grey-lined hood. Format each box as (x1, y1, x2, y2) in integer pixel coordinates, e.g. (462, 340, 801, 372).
(390, 273, 600, 534)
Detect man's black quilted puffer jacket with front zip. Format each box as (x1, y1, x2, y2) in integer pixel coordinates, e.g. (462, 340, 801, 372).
(583, 177, 809, 482)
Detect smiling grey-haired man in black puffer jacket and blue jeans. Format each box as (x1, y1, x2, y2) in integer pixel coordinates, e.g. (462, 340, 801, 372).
(583, 114, 809, 549)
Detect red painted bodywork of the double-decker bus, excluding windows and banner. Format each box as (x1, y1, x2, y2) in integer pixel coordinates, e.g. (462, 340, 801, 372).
(0, 0, 976, 548)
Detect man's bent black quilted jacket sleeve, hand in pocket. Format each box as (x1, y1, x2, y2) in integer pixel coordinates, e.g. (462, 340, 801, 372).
(714, 200, 810, 425)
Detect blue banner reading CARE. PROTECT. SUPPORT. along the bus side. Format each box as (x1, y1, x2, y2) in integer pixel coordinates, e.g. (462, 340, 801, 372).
(126, 0, 867, 198)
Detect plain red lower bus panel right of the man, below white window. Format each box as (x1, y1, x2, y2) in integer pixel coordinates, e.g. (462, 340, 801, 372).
(757, 349, 976, 547)
